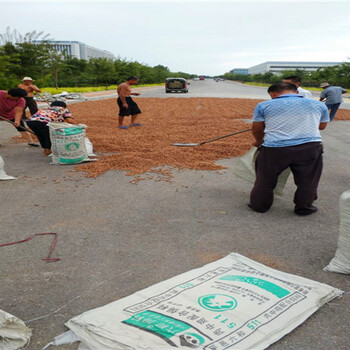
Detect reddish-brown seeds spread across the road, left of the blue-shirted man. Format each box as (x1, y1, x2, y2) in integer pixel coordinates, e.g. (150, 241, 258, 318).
(70, 98, 260, 182)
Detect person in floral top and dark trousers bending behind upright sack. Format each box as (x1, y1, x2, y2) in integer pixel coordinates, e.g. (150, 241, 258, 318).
(27, 101, 76, 156)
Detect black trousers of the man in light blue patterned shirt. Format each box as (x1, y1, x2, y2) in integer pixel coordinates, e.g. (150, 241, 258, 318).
(250, 142, 323, 213)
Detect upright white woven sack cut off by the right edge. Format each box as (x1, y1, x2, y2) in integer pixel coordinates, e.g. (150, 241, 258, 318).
(325, 190, 350, 273)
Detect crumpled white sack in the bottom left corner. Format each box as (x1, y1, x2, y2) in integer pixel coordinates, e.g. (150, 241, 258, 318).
(0, 310, 32, 350)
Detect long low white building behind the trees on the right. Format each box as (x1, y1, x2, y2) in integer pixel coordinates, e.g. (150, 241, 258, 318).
(248, 61, 341, 75)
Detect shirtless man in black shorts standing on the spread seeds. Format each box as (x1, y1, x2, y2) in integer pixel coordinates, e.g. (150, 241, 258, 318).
(117, 77, 142, 129)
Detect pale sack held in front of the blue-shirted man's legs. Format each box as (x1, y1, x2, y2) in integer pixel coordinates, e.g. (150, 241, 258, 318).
(233, 147, 291, 196)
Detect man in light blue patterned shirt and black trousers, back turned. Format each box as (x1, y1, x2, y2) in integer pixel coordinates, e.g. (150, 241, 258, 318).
(249, 83, 329, 215)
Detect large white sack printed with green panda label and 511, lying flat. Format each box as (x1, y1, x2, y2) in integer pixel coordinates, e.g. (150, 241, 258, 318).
(45, 254, 342, 350)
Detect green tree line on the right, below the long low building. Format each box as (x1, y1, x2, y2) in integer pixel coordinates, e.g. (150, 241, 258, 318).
(222, 62, 350, 88)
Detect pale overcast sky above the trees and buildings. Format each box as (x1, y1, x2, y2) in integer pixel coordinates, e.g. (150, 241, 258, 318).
(0, 0, 350, 75)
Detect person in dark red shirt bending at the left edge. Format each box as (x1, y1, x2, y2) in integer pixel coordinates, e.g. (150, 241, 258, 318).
(0, 88, 38, 147)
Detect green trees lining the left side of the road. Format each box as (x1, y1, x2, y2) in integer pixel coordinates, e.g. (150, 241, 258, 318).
(0, 38, 195, 90)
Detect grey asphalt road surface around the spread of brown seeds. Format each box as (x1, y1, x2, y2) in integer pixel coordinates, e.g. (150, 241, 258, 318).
(0, 82, 350, 350)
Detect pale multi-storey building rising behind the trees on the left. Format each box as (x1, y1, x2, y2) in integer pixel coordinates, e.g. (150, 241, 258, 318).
(35, 40, 115, 60)
